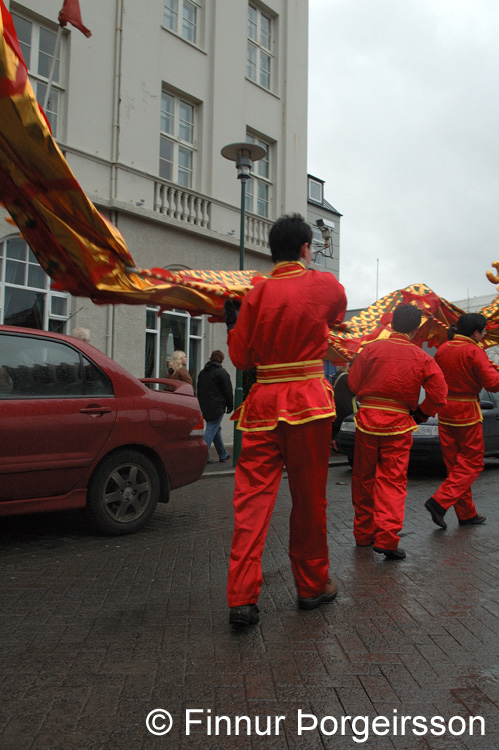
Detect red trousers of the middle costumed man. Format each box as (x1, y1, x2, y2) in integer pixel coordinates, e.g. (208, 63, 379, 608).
(352, 429, 412, 549)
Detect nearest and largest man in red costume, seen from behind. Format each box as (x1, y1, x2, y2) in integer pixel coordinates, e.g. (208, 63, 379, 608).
(225, 214, 346, 625)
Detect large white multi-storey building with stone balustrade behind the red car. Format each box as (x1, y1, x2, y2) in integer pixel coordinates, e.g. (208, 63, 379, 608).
(0, 0, 308, 418)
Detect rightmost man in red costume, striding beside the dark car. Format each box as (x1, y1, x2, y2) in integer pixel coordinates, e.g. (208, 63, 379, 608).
(425, 313, 499, 529)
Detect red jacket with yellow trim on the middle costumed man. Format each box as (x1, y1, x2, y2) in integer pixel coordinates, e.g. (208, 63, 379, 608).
(348, 333, 447, 435)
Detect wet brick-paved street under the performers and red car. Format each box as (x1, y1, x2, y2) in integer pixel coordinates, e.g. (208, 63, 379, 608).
(0, 459, 499, 750)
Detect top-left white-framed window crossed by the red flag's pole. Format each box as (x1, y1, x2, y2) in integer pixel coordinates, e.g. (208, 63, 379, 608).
(12, 13, 65, 138)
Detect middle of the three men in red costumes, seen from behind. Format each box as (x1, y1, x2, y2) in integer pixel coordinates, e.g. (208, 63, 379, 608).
(348, 304, 447, 560)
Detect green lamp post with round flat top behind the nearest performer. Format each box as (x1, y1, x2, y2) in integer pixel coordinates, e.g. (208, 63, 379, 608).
(221, 143, 267, 466)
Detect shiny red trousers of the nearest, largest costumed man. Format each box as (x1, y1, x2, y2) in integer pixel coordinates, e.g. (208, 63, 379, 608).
(227, 417, 332, 607)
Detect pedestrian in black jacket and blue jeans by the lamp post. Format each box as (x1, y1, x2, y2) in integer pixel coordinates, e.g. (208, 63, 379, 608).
(197, 349, 234, 464)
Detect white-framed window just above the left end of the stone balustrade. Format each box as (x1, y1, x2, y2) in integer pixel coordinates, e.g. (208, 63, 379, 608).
(159, 91, 196, 188)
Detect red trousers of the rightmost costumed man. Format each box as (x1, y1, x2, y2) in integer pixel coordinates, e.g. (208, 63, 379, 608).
(433, 422, 483, 521)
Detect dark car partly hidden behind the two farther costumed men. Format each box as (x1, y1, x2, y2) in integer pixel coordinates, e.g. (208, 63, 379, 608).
(336, 388, 499, 468)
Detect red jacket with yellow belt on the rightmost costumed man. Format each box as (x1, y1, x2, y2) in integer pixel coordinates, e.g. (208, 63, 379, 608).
(435, 333, 499, 427)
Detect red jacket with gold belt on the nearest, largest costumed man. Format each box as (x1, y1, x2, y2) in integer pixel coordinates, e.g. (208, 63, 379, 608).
(228, 261, 347, 432)
